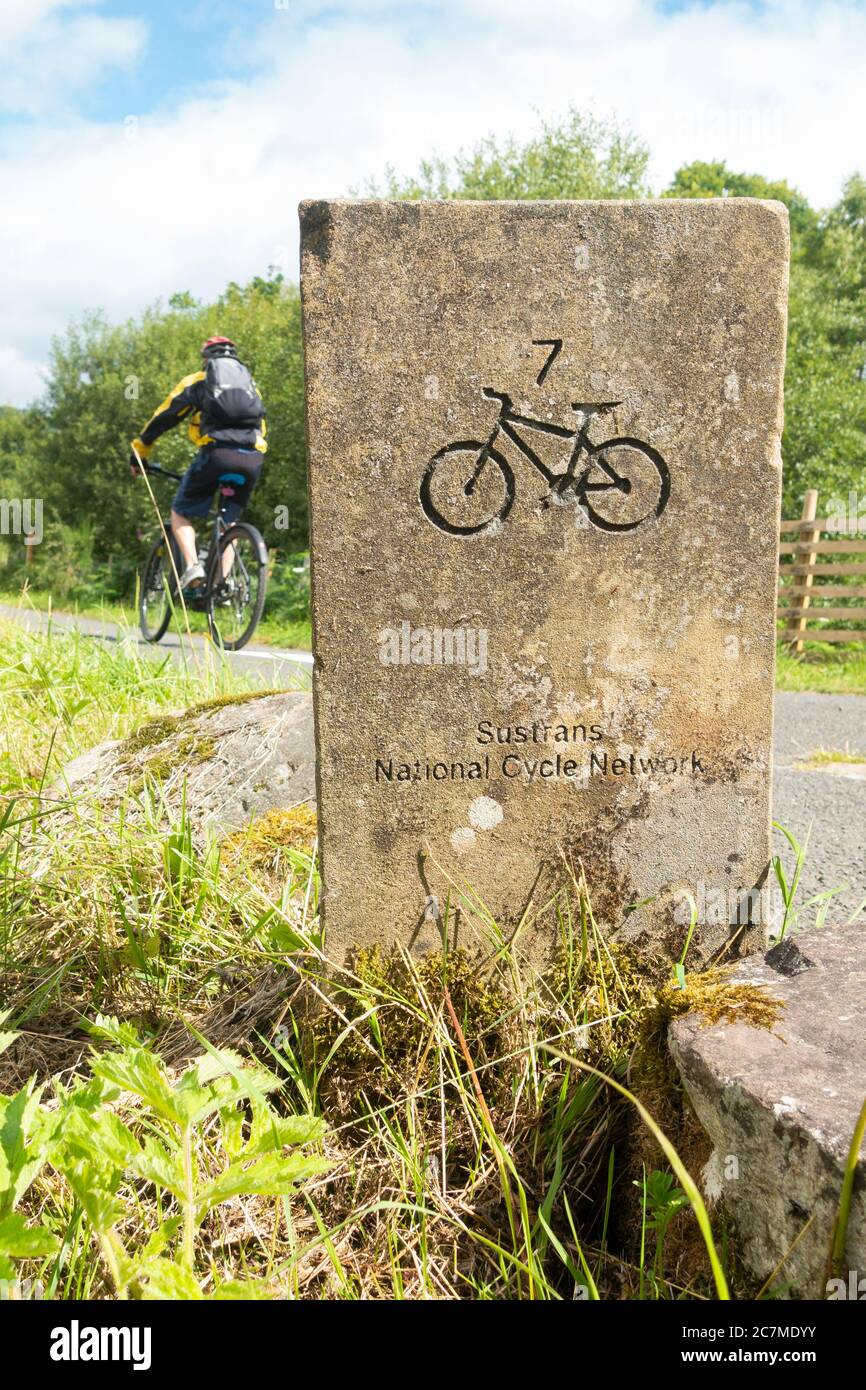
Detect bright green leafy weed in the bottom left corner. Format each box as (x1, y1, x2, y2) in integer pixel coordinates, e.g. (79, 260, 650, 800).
(0, 1017, 328, 1300)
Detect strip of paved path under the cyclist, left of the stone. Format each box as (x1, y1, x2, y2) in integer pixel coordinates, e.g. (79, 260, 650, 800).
(0, 603, 313, 689)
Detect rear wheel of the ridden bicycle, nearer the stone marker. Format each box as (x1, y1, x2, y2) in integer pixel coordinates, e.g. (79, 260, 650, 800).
(207, 521, 268, 652)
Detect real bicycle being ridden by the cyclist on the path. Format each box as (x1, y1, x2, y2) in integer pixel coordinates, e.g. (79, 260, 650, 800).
(139, 463, 268, 652)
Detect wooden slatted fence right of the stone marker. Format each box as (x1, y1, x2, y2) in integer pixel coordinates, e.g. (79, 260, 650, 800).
(777, 488, 866, 652)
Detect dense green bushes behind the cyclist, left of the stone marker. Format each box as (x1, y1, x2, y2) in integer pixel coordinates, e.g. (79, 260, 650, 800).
(0, 271, 307, 569)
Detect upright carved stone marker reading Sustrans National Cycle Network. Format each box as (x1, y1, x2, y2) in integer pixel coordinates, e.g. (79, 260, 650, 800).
(300, 199, 788, 963)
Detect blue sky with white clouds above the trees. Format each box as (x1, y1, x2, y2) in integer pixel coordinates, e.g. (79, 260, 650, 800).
(0, 0, 866, 403)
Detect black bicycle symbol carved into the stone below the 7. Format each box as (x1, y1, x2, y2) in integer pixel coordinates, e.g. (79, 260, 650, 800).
(420, 386, 670, 537)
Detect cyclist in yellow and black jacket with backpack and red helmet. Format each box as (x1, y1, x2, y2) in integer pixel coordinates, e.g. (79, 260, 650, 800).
(129, 338, 267, 589)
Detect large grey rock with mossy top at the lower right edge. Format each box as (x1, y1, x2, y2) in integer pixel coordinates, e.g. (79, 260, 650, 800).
(669, 924, 866, 1298)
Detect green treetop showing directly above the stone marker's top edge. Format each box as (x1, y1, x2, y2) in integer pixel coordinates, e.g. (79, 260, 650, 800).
(371, 107, 649, 199)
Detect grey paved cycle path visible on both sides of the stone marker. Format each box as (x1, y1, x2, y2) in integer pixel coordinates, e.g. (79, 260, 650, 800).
(0, 605, 866, 930)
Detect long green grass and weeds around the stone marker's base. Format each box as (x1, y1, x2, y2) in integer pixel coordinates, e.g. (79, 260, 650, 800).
(0, 624, 845, 1301)
